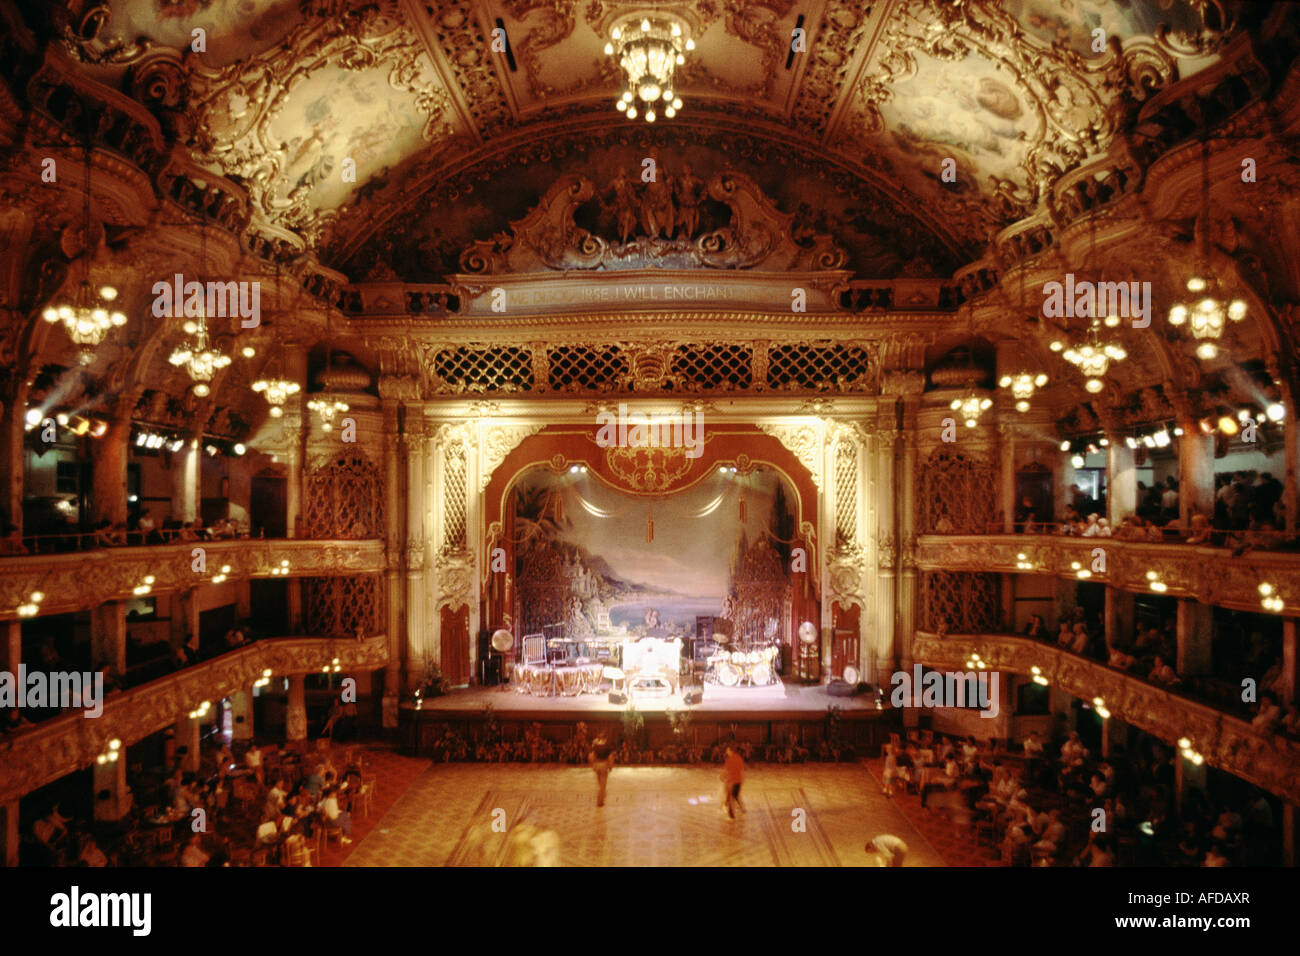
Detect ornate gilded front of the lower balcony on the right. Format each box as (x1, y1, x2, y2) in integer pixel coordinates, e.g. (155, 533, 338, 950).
(911, 631, 1300, 803)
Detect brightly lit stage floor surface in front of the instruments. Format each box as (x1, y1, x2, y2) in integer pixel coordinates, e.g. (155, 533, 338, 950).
(413, 684, 878, 719)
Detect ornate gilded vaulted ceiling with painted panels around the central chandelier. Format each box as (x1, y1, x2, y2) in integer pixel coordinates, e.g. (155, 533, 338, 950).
(61, 0, 1222, 278)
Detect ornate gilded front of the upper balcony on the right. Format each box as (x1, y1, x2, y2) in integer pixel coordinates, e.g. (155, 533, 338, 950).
(917, 535, 1300, 614)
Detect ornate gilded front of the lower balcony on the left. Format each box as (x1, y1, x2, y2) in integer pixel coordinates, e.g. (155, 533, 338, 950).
(0, 636, 389, 804)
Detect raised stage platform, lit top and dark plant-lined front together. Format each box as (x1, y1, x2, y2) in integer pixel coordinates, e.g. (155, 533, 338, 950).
(398, 683, 900, 756)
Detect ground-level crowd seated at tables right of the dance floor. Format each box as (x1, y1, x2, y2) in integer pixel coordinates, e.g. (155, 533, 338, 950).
(881, 731, 1281, 866)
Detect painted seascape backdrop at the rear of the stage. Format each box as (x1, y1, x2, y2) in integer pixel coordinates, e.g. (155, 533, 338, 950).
(514, 468, 796, 640)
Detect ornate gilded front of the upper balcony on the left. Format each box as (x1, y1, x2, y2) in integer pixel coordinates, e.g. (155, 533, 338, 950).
(0, 538, 387, 620)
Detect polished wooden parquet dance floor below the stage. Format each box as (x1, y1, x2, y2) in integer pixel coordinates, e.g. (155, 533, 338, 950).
(345, 763, 944, 866)
